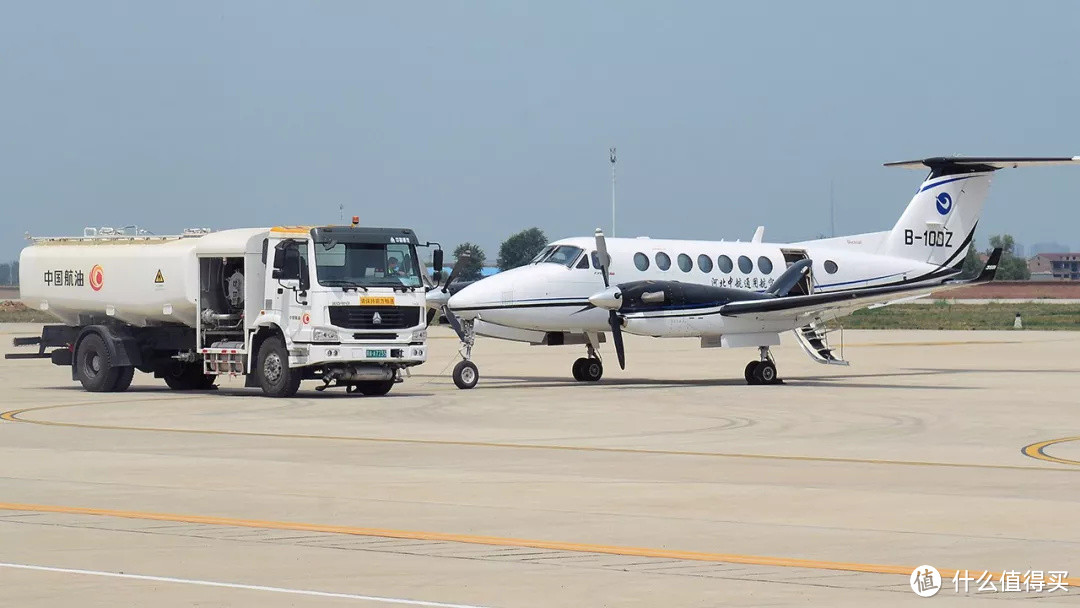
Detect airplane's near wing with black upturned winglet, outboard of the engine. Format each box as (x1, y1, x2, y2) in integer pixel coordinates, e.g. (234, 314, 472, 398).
(720, 248, 1001, 320)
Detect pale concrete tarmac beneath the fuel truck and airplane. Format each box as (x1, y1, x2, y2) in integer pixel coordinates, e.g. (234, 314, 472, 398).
(0, 324, 1080, 608)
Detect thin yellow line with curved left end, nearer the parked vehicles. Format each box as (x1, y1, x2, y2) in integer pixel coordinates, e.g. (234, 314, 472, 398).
(0, 397, 1080, 473)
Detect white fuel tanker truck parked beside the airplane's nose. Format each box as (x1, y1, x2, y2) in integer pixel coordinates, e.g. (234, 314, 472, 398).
(8, 224, 443, 396)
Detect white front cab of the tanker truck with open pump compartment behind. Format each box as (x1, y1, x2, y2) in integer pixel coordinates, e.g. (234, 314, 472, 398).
(198, 226, 427, 396)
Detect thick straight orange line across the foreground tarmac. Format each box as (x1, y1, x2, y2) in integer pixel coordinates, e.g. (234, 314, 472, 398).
(0, 502, 1080, 587)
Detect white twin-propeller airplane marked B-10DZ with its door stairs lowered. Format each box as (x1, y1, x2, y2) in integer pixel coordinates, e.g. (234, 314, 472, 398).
(429, 157, 1080, 389)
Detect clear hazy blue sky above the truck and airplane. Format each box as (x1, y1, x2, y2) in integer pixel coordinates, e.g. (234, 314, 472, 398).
(0, 1, 1080, 259)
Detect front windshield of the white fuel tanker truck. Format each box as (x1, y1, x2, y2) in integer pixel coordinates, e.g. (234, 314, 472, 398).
(314, 242, 421, 287)
